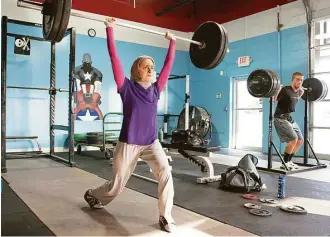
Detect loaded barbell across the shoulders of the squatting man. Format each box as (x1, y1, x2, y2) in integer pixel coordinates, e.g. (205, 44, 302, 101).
(247, 69, 328, 102)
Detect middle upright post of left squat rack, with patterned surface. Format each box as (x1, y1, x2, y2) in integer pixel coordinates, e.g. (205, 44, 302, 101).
(49, 42, 56, 156)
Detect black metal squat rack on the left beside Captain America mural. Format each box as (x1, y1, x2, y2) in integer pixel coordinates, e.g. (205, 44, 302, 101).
(1, 16, 76, 173)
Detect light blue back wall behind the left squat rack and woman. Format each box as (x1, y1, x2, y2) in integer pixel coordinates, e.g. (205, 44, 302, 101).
(7, 24, 189, 150)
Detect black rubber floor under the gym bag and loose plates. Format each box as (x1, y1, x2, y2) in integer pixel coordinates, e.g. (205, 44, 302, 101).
(67, 151, 330, 236)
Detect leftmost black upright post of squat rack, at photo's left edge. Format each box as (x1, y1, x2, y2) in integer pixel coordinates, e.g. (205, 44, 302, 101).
(1, 16, 8, 173)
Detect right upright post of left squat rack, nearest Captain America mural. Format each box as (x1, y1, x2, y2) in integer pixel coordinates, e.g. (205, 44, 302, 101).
(68, 28, 76, 166)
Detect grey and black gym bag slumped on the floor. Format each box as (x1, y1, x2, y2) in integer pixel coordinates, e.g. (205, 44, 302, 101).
(219, 154, 262, 193)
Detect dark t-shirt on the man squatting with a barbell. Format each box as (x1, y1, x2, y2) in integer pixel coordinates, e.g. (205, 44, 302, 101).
(274, 86, 299, 121)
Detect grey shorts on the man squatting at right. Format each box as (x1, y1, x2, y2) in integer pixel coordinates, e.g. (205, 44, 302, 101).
(274, 118, 303, 143)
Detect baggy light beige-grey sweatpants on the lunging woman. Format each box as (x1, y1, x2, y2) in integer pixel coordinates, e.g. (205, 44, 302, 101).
(92, 139, 174, 222)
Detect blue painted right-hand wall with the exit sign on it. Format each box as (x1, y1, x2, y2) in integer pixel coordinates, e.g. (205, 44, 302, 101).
(189, 26, 308, 155)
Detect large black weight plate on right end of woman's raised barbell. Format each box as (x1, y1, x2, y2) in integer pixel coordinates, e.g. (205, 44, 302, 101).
(189, 21, 226, 69)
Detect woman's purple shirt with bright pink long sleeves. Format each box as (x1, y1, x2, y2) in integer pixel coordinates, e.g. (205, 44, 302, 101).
(106, 27, 176, 146)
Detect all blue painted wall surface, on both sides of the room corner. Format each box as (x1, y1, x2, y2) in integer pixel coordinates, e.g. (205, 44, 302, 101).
(3, 21, 308, 156)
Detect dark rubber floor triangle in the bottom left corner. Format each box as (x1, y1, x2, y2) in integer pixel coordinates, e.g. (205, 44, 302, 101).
(1, 179, 55, 236)
